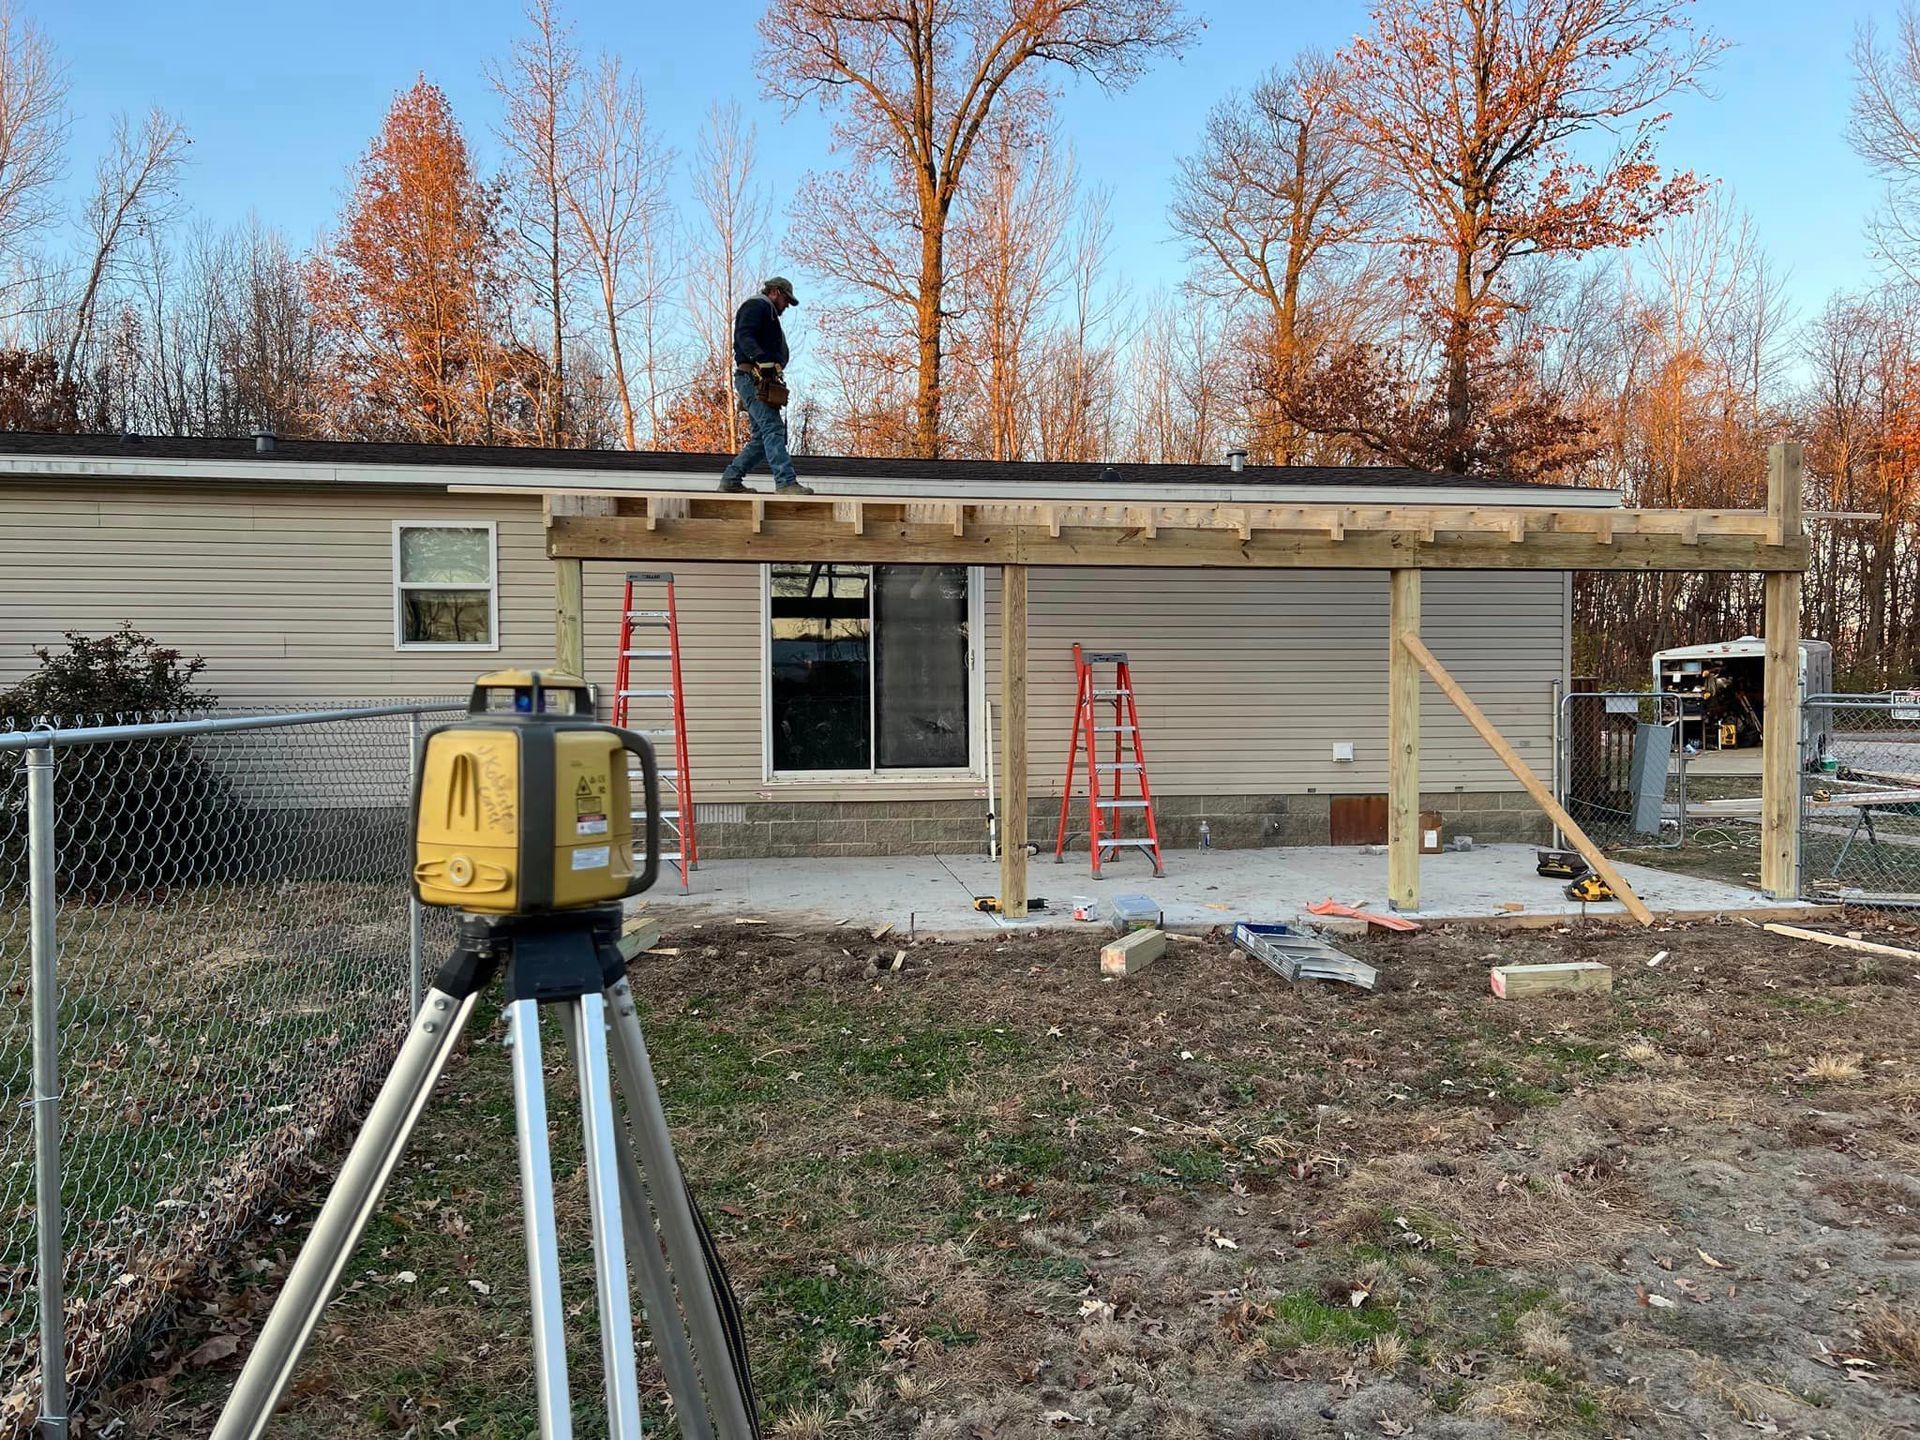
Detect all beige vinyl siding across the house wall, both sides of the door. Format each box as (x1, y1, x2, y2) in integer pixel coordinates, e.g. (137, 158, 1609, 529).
(0, 480, 1569, 803)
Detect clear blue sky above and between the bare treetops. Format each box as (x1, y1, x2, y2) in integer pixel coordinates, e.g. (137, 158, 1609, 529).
(30, 0, 1920, 332)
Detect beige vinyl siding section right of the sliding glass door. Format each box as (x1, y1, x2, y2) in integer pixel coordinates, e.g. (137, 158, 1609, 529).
(987, 570, 1567, 795)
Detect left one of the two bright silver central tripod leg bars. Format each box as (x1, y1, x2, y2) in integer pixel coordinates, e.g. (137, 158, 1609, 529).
(507, 1000, 574, 1440)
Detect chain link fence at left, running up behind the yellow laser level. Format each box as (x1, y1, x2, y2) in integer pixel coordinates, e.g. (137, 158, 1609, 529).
(0, 703, 461, 1436)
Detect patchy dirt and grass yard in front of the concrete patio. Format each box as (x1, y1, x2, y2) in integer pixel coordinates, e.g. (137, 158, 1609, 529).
(94, 922, 1920, 1440)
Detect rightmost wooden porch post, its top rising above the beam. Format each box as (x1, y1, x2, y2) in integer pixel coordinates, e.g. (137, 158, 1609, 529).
(1761, 444, 1803, 900)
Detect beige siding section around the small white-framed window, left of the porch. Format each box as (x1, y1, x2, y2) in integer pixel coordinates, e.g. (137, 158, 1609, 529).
(0, 484, 553, 707)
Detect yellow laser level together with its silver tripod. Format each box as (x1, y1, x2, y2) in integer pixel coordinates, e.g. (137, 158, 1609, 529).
(213, 670, 760, 1440)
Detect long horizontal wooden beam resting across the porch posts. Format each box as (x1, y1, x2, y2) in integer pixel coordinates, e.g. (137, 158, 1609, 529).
(547, 510, 1809, 572)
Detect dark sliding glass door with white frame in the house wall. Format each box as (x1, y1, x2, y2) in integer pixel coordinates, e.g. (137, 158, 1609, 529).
(766, 564, 975, 774)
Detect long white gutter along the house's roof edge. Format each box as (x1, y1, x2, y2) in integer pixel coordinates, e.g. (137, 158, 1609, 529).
(0, 453, 1620, 511)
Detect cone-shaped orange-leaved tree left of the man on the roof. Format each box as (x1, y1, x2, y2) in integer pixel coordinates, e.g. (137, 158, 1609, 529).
(307, 77, 533, 444)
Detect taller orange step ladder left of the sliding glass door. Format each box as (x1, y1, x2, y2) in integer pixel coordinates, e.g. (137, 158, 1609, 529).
(612, 570, 701, 891)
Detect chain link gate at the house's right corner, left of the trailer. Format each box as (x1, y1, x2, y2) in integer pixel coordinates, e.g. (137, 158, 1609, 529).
(1555, 691, 1686, 849)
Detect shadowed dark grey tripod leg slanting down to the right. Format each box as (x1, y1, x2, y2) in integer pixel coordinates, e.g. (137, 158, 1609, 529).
(607, 975, 756, 1440)
